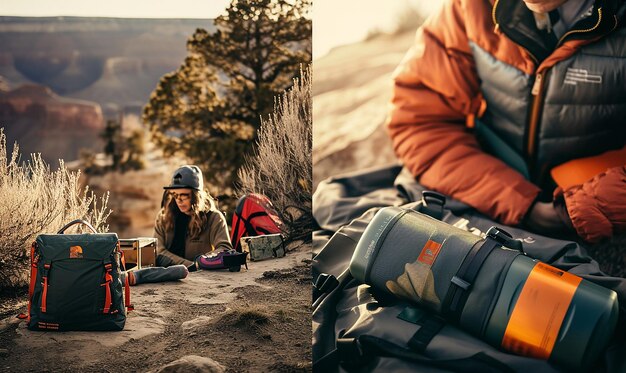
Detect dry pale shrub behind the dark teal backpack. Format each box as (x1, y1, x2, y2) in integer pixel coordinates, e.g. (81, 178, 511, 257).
(0, 128, 111, 288)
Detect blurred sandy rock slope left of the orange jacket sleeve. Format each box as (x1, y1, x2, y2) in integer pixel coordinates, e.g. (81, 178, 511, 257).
(313, 31, 414, 188)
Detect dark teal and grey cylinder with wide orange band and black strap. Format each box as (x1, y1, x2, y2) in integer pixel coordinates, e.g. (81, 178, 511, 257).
(350, 207, 618, 370)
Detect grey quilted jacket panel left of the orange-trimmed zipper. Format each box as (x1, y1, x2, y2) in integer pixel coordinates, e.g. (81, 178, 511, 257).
(470, 42, 530, 152)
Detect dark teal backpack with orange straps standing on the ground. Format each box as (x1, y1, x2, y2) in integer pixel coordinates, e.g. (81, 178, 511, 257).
(27, 220, 132, 331)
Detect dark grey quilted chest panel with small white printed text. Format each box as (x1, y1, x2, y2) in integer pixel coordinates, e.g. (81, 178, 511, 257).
(538, 29, 626, 165)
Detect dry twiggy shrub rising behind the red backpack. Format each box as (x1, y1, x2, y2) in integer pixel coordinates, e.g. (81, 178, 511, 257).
(238, 66, 313, 240)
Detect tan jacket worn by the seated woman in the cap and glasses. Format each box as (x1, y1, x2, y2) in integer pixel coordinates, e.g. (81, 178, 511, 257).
(154, 208, 233, 266)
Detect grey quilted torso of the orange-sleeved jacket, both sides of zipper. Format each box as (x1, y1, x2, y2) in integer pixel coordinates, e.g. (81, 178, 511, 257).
(470, 1, 626, 184)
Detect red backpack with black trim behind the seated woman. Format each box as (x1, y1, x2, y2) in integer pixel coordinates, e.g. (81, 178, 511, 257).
(230, 193, 284, 251)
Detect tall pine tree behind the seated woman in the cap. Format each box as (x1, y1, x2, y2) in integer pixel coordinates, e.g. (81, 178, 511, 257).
(143, 0, 311, 193)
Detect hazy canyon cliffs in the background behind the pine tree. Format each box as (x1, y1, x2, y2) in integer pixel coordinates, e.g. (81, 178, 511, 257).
(0, 17, 213, 166)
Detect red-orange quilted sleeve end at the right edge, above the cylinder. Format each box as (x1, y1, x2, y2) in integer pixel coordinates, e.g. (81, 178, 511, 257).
(555, 166, 626, 243)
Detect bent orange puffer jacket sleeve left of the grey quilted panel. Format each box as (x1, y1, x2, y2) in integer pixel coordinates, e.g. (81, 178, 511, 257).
(387, 0, 539, 225)
